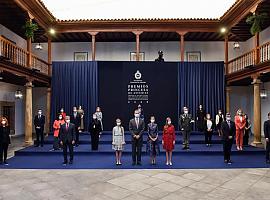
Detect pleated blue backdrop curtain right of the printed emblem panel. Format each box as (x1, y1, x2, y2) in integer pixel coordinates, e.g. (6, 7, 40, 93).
(178, 62, 225, 126)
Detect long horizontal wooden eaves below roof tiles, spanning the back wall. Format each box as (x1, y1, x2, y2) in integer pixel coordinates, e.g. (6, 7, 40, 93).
(55, 20, 219, 33)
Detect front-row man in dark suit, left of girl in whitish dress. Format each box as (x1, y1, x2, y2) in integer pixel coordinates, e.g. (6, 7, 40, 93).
(59, 116, 75, 165)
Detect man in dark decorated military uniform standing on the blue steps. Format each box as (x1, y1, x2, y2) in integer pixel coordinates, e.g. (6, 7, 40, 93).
(179, 107, 194, 150)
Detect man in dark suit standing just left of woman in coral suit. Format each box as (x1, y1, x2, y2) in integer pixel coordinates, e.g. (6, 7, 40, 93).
(221, 113, 236, 164)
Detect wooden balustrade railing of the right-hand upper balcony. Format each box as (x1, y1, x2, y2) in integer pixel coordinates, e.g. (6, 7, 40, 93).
(227, 42, 270, 74)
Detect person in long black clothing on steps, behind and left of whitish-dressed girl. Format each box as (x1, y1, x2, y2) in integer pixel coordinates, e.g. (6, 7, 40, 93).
(88, 114, 102, 150)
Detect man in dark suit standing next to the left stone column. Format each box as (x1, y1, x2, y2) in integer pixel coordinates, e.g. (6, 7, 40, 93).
(34, 109, 45, 147)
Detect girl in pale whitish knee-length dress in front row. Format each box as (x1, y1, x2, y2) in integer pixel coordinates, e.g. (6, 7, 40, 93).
(112, 119, 125, 165)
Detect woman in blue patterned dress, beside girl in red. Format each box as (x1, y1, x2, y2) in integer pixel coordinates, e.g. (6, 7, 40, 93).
(146, 116, 159, 165)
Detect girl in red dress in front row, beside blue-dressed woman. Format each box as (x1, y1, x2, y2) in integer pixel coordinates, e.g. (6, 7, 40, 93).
(162, 117, 175, 165)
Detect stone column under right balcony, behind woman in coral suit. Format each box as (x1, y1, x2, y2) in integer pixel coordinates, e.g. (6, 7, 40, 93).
(252, 77, 261, 146)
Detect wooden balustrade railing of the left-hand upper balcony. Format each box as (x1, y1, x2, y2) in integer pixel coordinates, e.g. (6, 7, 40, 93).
(0, 36, 50, 75)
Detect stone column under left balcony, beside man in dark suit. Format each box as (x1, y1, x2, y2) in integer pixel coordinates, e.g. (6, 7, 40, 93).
(24, 81, 33, 145)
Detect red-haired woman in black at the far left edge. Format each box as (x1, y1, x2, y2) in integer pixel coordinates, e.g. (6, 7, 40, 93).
(0, 117, 10, 165)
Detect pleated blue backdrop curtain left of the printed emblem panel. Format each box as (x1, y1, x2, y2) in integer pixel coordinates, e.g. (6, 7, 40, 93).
(51, 61, 98, 130)
